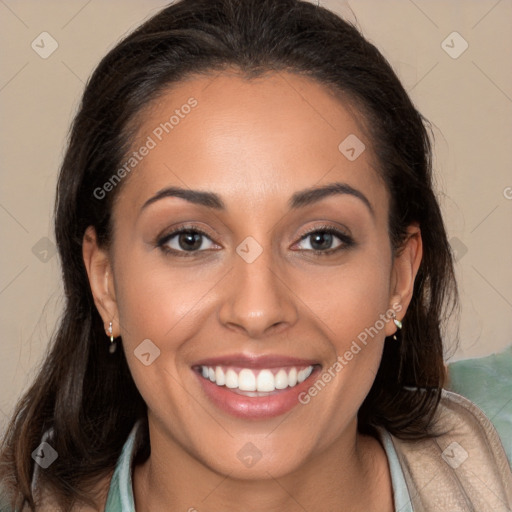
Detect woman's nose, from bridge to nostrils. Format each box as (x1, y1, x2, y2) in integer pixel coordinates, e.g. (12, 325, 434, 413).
(219, 241, 298, 339)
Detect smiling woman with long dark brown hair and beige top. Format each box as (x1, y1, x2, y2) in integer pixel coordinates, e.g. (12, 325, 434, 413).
(1, 0, 512, 512)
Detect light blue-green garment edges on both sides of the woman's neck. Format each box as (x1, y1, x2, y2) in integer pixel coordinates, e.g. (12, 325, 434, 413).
(105, 422, 413, 512)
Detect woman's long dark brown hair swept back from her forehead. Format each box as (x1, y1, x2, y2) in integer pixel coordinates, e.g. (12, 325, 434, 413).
(0, 0, 457, 510)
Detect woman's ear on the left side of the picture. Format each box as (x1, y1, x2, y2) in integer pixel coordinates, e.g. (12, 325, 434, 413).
(82, 226, 119, 337)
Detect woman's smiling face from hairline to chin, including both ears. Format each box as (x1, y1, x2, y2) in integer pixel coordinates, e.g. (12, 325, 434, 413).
(84, 73, 421, 478)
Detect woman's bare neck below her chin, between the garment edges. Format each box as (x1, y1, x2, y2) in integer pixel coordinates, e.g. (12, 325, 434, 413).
(133, 420, 394, 512)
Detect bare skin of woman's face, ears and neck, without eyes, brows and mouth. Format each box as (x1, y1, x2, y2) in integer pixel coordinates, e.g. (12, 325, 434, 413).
(83, 72, 422, 512)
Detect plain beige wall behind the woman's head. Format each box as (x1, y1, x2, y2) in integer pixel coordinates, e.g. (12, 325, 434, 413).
(0, 0, 512, 427)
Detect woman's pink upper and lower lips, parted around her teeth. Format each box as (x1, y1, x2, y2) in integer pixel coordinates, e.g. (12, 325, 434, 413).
(192, 354, 321, 420)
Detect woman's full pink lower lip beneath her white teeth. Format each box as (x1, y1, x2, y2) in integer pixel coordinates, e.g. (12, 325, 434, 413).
(194, 366, 320, 420)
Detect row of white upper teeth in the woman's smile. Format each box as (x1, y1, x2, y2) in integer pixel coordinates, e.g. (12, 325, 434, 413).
(201, 366, 313, 392)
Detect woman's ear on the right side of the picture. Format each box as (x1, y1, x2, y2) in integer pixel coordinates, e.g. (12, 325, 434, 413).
(386, 223, 423, 336)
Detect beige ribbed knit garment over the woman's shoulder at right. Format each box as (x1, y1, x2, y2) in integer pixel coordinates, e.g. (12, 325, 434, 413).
(392, 390, 512, 512)
